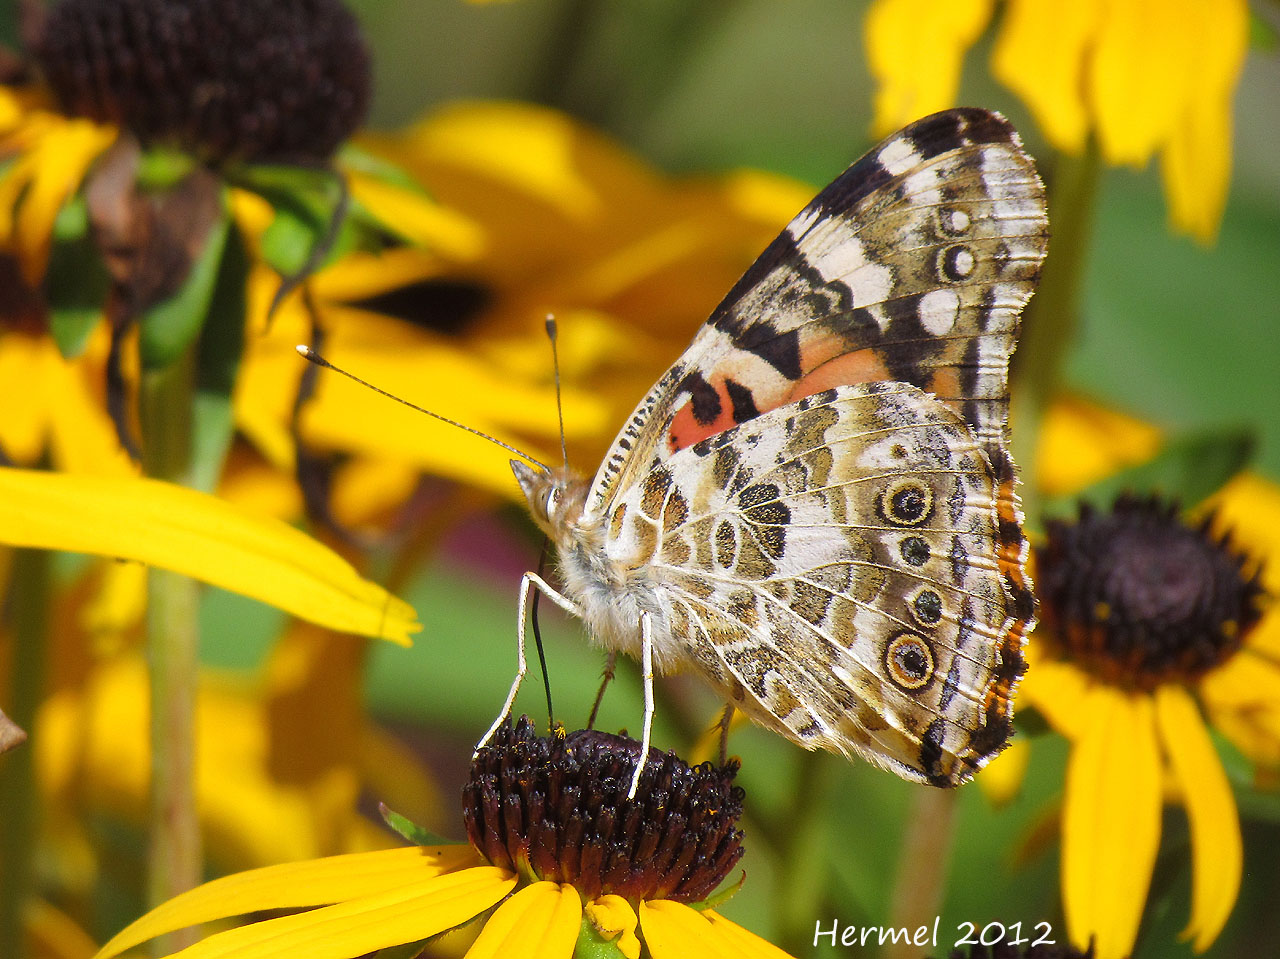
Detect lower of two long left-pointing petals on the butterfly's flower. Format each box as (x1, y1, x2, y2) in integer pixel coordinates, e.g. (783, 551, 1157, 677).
(104, 866, 516, 959)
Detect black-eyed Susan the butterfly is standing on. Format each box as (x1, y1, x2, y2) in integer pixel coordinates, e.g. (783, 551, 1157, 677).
(97, 720, 786, 959)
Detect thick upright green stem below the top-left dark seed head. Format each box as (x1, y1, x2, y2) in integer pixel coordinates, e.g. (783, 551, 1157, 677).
(141, 355, 202, 955)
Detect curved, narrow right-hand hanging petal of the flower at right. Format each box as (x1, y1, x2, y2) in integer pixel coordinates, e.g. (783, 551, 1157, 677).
(1156, 684, 1244, 953)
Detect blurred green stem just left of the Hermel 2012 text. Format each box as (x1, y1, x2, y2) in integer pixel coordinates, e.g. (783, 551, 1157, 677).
(776, 752, 835, 955)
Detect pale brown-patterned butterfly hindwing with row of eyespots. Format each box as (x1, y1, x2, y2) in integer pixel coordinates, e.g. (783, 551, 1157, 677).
(607, 383, 1009, 785)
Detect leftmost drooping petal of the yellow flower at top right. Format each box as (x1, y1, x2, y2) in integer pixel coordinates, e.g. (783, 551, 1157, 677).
(865, 0, 992, 136)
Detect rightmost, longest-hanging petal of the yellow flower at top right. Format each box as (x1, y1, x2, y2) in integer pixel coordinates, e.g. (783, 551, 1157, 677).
(1161, 0, 1249, 243)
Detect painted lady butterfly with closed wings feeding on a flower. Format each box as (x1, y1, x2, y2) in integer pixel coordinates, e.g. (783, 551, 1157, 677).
(483, 109, 1048, 793)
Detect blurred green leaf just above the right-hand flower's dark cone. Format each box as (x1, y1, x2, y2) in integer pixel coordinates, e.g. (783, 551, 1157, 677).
(1044, 426, 1257, 516)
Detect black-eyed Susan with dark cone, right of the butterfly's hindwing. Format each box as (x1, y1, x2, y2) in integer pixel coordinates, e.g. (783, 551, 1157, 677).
(1021, 490, 1280, 959)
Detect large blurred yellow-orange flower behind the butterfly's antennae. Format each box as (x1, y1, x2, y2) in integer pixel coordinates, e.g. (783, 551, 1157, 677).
(258, 102, 810, 498)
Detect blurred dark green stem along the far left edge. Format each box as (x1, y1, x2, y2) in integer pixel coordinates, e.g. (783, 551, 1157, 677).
(0, 549, 50, 955)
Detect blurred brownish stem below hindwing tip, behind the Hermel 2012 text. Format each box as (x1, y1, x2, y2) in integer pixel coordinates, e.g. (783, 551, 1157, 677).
(882, 786, 959, 959)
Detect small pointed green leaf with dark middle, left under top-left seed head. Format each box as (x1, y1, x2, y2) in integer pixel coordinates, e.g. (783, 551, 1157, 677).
(45, 196, 111, 360)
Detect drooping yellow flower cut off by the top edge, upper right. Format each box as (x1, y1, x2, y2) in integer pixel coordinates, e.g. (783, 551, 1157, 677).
(867, 0, 1249, 241)
